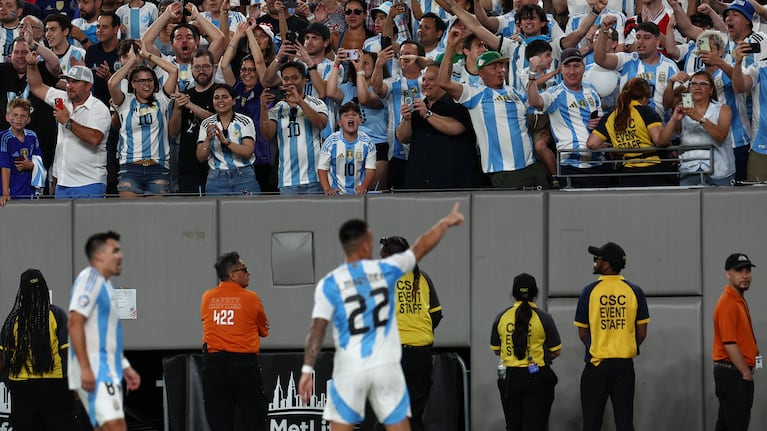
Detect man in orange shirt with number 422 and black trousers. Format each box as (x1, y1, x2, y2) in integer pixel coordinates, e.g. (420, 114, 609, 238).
(200, 251, 269, 431)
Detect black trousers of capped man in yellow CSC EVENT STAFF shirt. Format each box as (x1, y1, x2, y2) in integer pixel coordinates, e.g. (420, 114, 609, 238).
(581, 358, 635, 431)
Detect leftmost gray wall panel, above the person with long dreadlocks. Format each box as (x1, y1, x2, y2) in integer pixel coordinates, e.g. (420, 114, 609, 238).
(0, 201, 72, 312)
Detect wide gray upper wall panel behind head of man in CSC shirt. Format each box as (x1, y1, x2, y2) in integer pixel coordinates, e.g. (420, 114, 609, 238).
(548, 190, 701, 296)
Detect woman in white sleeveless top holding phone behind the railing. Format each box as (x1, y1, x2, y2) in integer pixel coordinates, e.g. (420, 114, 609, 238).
(668, 70, 735, 186)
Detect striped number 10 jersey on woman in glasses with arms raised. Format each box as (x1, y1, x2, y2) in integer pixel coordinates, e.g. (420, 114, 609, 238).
(117, 89, 170, 169)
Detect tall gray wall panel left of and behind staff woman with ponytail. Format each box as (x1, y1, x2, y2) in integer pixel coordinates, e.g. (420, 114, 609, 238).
(471, 193, 546, 430)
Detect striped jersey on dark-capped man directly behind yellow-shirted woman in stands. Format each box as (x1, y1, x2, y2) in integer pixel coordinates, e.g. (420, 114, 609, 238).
(615, 52, 679, 122)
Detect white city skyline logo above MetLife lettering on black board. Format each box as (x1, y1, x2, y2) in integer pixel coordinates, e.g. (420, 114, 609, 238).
(268, 371, 330, 431)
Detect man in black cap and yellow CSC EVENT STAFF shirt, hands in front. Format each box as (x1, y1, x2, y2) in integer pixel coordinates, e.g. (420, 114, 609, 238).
(575, 242, 650, 431)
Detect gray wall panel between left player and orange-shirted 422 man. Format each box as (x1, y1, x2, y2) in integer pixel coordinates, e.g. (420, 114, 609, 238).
(70, 199, 218, 349)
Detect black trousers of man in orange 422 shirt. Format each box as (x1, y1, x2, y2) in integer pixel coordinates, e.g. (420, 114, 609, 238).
(202, 352, 267, 431)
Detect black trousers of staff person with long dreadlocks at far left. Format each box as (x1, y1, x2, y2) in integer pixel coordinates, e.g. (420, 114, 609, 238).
(8, 379, 81, 431)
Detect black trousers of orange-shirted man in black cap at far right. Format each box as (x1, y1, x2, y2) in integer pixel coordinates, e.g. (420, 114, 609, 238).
(714, 365, 754, 431)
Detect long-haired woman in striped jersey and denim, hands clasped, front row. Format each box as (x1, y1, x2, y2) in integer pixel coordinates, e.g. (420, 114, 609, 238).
(196, 84, 261, 196)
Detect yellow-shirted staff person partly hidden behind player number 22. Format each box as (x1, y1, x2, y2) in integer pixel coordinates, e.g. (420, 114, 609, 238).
(381, 236, 442, 431)
